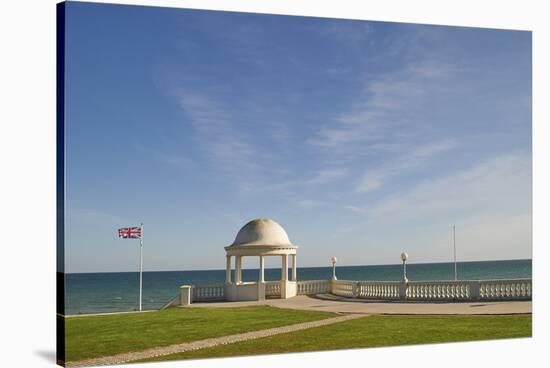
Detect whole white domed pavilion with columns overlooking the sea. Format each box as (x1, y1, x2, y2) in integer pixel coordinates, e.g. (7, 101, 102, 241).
(225, 218, 298, 300)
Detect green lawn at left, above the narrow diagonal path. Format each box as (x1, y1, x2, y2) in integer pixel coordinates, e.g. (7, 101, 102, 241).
(65, 306, 335, 361)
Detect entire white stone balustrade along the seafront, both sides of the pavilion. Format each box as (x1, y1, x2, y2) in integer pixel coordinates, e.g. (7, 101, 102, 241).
(170, 279, 533, 307)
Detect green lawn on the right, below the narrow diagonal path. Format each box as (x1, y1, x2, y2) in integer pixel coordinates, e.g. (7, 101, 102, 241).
(142, 315, 531, 361)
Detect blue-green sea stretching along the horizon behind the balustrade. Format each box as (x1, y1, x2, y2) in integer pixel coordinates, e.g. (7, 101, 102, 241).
(65, 260, 532, 315)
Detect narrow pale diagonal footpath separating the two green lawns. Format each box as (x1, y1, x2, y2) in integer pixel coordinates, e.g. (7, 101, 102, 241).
(66, 314, 364, 367)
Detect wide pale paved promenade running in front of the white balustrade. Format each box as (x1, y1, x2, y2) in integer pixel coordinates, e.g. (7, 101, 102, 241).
(185, 294, 532, 315)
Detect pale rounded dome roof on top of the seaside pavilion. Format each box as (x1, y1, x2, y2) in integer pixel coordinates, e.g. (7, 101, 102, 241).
(230, 218, 293, 247)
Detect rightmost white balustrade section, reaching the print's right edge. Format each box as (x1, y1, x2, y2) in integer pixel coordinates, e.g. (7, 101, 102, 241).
(479, 279, 533, 300)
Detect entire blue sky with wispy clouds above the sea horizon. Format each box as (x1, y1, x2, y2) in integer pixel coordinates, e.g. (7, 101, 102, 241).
(65, 3, 532, 272)
